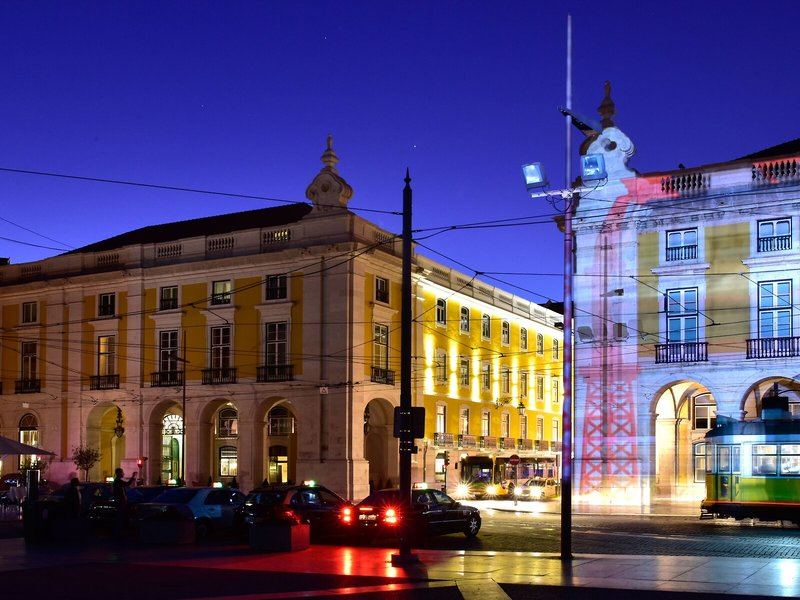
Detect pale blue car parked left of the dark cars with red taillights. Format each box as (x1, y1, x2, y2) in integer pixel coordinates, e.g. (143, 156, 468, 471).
(135, 487, 245, 538)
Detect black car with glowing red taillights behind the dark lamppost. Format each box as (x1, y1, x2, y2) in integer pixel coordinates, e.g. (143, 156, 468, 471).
(354, 489, 481, 539)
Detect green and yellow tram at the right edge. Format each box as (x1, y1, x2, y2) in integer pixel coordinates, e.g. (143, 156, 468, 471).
(700, 398, 800, 525)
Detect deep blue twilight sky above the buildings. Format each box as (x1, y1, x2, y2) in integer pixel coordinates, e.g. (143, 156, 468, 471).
(0, 0, 800, 301)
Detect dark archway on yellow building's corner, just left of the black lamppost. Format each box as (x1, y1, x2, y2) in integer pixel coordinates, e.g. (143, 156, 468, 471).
(361, 398, 399, 489)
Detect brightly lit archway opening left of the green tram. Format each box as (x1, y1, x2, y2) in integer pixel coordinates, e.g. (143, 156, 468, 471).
(647, 379, 718, 500)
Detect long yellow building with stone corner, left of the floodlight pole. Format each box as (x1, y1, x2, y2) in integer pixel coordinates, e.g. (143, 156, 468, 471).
(0, 141, 561, 500)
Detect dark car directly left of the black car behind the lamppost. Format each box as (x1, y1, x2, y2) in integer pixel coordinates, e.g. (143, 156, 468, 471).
(238, 482, 353, 539)
